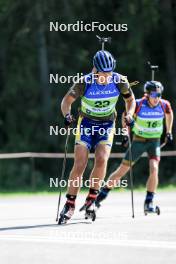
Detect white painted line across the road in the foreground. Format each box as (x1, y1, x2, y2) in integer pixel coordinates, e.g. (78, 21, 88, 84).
(0, 235, 176, 250)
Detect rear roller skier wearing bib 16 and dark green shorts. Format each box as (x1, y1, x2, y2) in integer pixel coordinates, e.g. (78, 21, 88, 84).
(95, 81, 173, 214)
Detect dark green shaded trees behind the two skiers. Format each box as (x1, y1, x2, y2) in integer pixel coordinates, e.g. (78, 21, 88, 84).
(0, 0, 176, 190)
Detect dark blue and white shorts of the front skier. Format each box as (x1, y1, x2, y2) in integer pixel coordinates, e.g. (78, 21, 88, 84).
(75, 117, 114, 150)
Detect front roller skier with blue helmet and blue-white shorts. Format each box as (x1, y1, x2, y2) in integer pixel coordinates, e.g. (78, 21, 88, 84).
(60, 50, 136, 223)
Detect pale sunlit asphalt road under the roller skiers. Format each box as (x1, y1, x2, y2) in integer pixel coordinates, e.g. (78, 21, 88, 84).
(0, 192, 176, 264)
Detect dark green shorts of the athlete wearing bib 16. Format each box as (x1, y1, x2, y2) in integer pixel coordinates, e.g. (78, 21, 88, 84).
(122, 140, 160, 164)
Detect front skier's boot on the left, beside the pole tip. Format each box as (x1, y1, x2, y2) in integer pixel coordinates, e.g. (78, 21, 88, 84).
(58, 202, 75, 225)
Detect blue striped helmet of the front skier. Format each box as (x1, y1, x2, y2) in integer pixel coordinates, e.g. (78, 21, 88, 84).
(93, 50, 116, 72)
